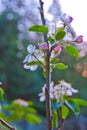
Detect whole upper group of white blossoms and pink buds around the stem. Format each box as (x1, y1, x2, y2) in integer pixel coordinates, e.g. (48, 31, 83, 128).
(23, 14, 83, 71)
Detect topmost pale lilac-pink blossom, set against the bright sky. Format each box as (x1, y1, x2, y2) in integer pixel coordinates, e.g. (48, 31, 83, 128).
(60, 13, 73, 25)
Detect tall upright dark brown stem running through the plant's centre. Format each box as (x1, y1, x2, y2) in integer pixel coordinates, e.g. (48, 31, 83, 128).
(39, 0, 53, 130)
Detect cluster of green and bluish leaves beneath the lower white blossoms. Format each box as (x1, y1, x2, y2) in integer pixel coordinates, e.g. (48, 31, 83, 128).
(52, 98, 87, 128)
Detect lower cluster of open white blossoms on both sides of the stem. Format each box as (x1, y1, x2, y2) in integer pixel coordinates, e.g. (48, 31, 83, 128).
(39, 80, 78, 102)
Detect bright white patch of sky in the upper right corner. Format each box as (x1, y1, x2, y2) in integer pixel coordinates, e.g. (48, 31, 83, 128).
(59, 0, 87, 41)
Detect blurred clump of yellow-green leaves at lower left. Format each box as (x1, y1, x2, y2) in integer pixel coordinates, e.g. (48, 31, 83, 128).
(0, 101, 41, 124)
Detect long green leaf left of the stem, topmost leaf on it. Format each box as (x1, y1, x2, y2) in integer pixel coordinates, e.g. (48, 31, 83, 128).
(29, 25, 48, 34)
